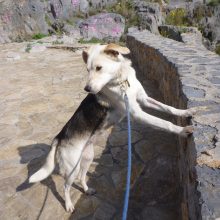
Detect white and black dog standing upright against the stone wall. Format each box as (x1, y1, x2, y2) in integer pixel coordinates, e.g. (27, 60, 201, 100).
(29, 44, 194, 212)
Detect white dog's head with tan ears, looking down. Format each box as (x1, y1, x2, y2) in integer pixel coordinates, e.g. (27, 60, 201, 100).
(82, 44, 130, 94)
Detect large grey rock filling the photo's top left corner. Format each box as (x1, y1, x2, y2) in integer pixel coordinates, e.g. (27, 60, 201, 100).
(0, 0, 48, 43)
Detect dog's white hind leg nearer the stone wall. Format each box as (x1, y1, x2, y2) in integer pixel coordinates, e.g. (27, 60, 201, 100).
(79, 143, 95, 195)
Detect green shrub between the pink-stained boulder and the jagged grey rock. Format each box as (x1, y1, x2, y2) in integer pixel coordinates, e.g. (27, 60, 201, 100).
(107, 0, 140, 32)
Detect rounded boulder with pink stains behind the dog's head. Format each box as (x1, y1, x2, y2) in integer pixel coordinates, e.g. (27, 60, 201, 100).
(80, 13, 125, 40)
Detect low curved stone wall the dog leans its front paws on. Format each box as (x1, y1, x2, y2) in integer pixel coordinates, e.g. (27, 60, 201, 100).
(127, 29, 220, 220)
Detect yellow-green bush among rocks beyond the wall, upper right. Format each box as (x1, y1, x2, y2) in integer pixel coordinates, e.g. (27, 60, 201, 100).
(165, 8, 190, 26)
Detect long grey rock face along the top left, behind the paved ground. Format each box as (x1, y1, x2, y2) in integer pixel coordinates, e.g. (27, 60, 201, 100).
(0, 0, 116, 43)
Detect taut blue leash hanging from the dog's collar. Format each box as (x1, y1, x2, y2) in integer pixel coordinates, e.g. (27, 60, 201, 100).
(122, 93, 131, 220)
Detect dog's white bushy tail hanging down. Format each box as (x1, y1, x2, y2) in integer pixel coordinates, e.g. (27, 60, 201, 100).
(29, 139, 58, 183)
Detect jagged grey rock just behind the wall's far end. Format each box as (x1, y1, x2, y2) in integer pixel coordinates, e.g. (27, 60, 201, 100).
(134, 1, 163, 34)
